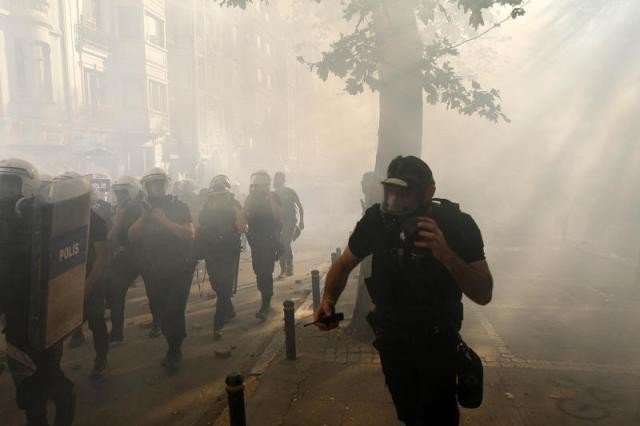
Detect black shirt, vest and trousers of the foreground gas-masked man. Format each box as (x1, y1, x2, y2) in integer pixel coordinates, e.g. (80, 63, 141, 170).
(349, 201, 485, 426)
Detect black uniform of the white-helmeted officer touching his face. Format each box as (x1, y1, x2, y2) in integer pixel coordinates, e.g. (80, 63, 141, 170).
(138, 195, 195, 357)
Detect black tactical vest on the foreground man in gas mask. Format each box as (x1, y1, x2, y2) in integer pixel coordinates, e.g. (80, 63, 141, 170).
(365, 199, 465, 330)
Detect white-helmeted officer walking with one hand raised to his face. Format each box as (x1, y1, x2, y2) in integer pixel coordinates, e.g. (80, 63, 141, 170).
(128, 168, 195, 373)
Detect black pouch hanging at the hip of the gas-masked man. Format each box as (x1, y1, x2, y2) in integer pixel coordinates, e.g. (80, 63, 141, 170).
(456, 338, 483, 408)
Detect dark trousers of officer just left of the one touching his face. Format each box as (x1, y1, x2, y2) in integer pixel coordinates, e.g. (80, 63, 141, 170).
(107, 251, 138, 336)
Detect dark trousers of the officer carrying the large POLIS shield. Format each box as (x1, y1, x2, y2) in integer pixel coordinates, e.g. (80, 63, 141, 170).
(9, 342, 75, 426)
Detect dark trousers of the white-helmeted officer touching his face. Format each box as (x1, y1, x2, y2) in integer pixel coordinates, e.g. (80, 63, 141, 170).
(145, 263, 195, 351)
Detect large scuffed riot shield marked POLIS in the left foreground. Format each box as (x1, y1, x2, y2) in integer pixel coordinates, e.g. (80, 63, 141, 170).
(29, 176, 91, 349)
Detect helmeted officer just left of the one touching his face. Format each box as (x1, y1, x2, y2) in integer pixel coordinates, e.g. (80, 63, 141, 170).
(108, 176, 144, 343)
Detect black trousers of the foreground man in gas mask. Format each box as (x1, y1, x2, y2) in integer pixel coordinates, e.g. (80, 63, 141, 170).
(374, 334, 460, 426)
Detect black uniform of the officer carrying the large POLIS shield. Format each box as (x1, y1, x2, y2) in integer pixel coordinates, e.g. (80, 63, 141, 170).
(0, 199, 75, 425)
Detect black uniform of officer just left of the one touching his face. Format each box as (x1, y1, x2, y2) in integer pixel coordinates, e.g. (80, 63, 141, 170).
(108, 201, 145, 340)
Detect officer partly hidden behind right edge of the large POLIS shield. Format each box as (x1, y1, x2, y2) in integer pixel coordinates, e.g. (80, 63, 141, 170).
(53, 172, 109, 380)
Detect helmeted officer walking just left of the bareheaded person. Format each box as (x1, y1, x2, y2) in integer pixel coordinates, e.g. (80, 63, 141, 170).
(243, 170, 282, 321)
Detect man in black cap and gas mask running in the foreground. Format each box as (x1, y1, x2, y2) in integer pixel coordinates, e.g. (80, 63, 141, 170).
(314, 156, 493, 425)
